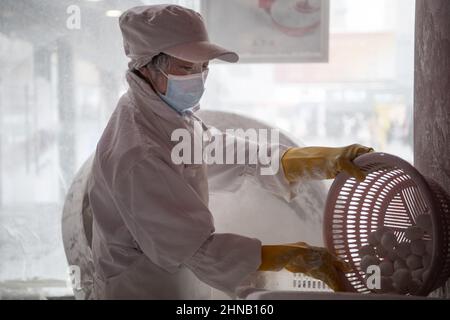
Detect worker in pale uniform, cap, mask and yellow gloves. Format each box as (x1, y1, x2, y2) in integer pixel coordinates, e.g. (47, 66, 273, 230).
(88, 5, 371, 299)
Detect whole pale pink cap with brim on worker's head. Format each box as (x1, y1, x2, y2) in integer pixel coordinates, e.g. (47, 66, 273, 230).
(119, 4, 239, 69)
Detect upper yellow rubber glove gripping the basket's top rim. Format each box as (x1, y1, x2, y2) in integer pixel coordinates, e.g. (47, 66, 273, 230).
(281, 144, 373, 182)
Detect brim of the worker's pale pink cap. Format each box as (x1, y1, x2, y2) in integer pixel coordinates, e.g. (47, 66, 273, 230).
(161, 41, 239, 63)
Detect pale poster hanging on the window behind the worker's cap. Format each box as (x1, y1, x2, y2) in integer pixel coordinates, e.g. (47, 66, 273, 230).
(201, 0, 329, 63)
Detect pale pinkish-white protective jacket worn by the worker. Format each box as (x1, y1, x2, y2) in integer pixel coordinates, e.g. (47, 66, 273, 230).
(88, 71, 295, 299)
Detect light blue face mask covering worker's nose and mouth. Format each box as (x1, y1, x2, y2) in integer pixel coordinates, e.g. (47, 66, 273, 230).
(158, 69, 208, 113)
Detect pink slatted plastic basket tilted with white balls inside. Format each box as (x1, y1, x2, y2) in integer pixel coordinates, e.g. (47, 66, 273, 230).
(324, 153, 450, 295)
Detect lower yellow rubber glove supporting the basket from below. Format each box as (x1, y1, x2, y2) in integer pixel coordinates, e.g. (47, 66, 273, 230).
(258, 242, 351, 291)
